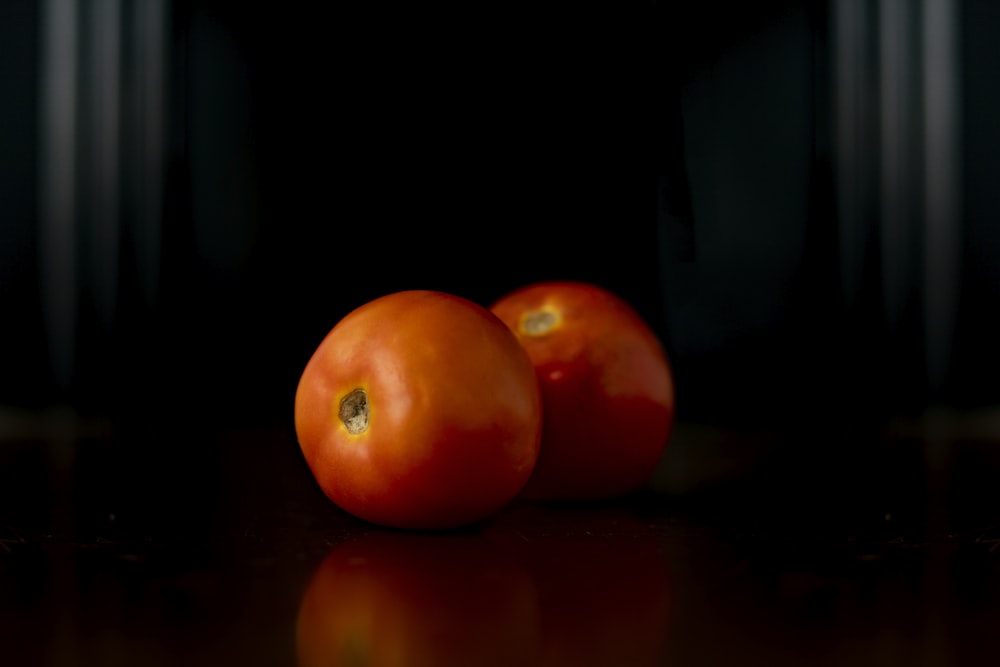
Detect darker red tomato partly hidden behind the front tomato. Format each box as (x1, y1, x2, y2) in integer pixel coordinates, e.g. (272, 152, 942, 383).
(491, 281, 674, 500)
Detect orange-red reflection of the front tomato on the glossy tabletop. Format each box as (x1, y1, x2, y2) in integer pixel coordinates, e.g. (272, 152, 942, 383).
(297, 533, 538, 667)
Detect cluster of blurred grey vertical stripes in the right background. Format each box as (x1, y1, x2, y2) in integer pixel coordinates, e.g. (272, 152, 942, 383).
(832, 0, 963, 393)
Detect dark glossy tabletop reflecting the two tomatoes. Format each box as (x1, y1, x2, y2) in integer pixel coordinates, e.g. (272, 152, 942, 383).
(0, 411, 1000, 667)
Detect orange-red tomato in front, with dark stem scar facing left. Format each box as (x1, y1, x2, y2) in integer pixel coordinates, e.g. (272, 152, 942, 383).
(295, 290, 542, 529)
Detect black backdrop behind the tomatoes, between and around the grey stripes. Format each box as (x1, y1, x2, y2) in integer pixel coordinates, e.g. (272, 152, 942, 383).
(0, 0, 1000, 430)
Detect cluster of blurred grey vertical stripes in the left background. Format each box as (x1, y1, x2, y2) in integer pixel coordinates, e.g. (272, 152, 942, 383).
(38, 0, 168, 402)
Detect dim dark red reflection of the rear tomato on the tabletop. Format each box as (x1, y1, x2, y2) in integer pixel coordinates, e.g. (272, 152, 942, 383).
(486, 505, 670, 667)
